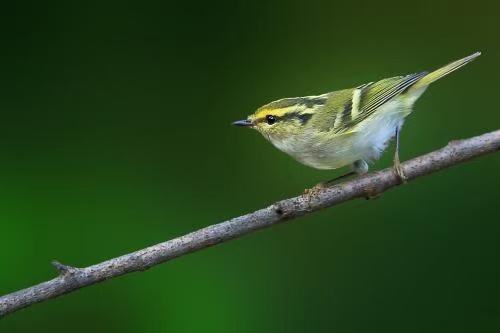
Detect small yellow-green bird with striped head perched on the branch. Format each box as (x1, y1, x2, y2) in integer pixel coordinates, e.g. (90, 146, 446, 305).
(233, 52, 481, 182)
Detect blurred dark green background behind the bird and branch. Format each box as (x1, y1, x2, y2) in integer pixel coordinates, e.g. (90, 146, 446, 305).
(0, 0, 500, 333)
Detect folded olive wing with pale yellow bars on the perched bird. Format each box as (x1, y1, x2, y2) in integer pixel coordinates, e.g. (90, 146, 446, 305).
(334, 72, 427, 133)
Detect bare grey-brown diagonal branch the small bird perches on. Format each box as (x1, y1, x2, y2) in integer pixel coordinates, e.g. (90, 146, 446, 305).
(0, 130, 500, 317)
